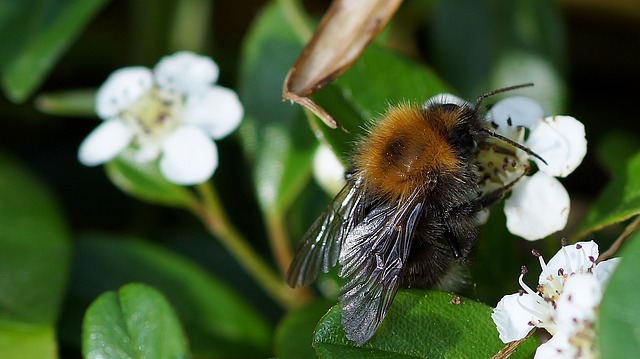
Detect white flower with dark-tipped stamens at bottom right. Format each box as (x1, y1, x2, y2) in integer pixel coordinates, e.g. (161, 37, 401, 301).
(491, 241, 620, 358)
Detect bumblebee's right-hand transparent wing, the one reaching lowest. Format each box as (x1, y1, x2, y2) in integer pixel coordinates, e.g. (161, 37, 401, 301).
(339, 191, 423, 345)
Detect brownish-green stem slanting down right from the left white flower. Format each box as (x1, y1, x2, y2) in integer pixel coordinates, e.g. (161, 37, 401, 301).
(192, 182, 306, 308)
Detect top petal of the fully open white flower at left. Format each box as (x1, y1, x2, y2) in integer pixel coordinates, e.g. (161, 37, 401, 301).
(153, 51, 220, 94)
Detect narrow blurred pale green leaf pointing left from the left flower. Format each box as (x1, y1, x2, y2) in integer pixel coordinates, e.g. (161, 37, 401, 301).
(35, 89, 96, 118)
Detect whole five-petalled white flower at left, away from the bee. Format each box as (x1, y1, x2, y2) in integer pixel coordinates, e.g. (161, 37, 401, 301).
(78, 52, 244, 185)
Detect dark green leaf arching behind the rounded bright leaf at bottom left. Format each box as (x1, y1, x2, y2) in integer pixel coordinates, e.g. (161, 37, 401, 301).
(71, 235, 270, 358)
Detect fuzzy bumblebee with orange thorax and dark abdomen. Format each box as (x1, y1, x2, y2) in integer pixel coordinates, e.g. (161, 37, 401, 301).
(286, 84, 538, 345)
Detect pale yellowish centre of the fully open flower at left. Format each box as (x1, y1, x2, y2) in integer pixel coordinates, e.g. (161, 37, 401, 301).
(121, 86, 184, 151)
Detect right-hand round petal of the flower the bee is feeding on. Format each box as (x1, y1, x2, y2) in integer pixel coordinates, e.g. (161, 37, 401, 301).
(525, 116, 587, 177)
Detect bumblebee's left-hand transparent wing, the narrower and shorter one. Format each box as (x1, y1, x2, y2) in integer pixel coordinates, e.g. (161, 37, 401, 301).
(286, 176, 367, 287)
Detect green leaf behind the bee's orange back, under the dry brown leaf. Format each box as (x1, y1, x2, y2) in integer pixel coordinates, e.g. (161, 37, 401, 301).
(313, 44, 447, 156)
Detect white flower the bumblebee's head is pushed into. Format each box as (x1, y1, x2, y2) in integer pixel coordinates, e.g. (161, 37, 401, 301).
(487, 96, 587, 240)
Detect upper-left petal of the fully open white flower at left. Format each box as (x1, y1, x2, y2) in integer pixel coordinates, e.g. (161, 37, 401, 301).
(96, 67, 153, 119)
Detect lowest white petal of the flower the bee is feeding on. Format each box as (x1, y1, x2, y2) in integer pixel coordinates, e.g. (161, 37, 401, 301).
(504, 172, 570, 241)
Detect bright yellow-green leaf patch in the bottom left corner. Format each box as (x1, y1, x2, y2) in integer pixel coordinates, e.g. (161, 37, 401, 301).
(0, 323, 58, 359)
